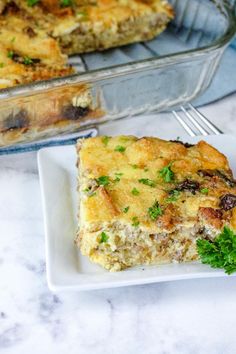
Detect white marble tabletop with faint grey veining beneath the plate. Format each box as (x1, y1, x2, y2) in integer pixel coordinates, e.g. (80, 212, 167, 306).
(0, 95, 236, 354)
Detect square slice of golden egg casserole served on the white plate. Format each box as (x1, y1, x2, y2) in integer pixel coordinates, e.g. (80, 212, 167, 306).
(76, 136, 236, 271)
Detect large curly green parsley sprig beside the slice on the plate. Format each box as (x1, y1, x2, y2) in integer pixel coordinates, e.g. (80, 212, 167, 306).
(197, 226, 236, 274)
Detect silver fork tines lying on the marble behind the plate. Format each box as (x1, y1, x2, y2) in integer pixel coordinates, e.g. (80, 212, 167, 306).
(172, 103, 223, 136)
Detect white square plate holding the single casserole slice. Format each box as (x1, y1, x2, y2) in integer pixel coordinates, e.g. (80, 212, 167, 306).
(38, 135, 236, 291)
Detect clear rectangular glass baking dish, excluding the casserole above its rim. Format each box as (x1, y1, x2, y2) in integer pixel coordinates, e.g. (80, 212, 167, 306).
(0, 0, 236, 151)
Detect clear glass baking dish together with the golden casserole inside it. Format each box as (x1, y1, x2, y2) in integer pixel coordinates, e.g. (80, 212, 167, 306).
(0, 0, 236, 154)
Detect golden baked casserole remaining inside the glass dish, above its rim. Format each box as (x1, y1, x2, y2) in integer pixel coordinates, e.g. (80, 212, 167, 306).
(0, 0, 173, 88)
